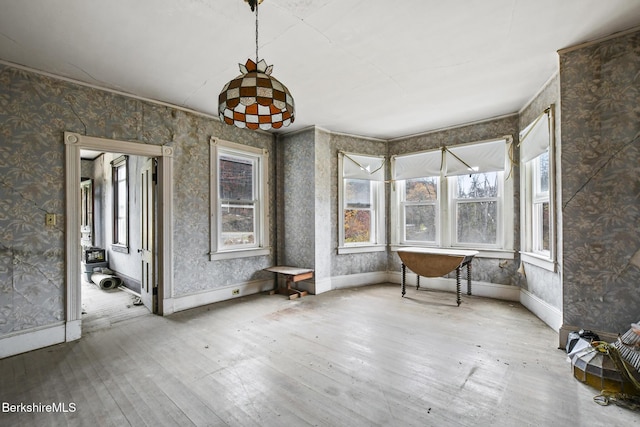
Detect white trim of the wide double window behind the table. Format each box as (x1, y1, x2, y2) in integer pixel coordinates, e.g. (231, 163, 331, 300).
(389, 135, 515, 259)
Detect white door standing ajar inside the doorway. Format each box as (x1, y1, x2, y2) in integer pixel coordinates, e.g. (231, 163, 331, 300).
(139, 159, 158, 313)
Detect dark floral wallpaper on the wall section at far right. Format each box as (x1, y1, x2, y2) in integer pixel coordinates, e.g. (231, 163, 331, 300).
(560, 32, 640, 333)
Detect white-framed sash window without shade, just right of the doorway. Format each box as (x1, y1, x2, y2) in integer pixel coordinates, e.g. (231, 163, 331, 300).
(210, 138, 270, 260)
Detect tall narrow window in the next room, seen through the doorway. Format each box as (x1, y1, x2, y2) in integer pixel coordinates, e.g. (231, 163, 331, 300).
(111, 156, 129, 252)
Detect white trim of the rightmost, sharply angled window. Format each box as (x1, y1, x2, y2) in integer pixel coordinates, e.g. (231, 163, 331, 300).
(520, 108, 557, 272)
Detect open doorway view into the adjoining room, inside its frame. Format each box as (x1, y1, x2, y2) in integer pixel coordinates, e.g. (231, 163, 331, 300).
(80, 150, 151, 333)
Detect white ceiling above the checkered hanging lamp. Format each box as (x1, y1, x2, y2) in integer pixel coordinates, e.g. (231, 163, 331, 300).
(0, 0, 640, 139)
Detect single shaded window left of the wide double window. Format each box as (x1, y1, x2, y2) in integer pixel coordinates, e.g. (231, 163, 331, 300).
(338, 152, 385, 253)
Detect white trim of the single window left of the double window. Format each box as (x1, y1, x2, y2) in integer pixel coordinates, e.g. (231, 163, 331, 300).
(338, 152, 387, 255)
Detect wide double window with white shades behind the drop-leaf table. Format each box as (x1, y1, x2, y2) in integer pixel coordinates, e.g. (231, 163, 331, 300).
(391, 138, 513, 258)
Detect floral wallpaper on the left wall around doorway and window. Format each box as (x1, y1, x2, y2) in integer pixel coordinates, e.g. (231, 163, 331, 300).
(0, 65, 275, 336)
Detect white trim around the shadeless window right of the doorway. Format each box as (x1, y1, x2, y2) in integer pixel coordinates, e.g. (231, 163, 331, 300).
(209, 137, 271, 261)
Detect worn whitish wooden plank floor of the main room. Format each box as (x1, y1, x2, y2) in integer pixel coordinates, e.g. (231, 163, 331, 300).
(0, 285, 640, 427)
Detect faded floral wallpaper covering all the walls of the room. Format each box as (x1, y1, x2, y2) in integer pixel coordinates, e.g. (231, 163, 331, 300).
(0, 26, 640, 344)
